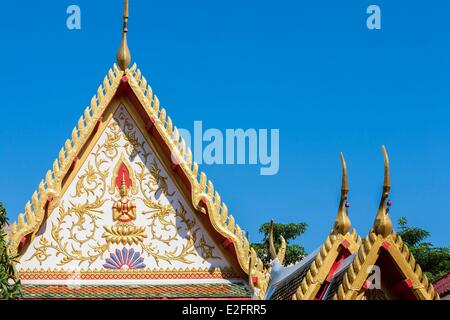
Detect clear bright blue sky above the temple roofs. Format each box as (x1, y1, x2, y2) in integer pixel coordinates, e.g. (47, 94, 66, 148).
(0, 0, 450, 251)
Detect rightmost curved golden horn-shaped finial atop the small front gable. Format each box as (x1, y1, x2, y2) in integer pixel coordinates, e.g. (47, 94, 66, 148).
(373, 146, 392, 237)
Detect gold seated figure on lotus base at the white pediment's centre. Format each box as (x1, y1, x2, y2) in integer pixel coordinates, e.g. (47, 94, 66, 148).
(102, 171, 147, 245)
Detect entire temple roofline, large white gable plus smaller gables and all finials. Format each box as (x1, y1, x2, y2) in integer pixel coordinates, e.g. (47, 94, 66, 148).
(9, 0, 442, 300)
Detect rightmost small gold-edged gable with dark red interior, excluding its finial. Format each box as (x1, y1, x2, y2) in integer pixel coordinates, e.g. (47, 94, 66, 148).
(333, 230, 439, 300)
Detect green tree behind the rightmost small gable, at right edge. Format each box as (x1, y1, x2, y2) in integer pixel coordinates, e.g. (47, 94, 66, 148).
(398, 217, 450, 282)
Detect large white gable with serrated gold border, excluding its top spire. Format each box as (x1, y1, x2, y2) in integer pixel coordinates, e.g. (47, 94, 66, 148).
(10, 65, 265, 292)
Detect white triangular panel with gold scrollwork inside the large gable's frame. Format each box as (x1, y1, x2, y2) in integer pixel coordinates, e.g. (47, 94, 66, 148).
(19, 100, 236, 273)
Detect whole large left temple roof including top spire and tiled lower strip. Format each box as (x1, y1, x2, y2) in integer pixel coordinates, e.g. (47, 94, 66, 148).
(9, 0, 267, 299)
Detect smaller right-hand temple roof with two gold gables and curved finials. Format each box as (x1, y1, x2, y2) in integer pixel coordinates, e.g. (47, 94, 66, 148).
(260, 146, 439, 300)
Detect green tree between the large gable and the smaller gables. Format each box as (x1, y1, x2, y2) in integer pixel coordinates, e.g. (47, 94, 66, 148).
(252, 222, 308, 267)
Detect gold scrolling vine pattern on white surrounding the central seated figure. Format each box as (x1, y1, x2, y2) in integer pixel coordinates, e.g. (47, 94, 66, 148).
(28, 106, 221, 266)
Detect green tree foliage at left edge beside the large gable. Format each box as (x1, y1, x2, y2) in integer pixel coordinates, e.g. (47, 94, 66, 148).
(0, 202, 22, 300)
